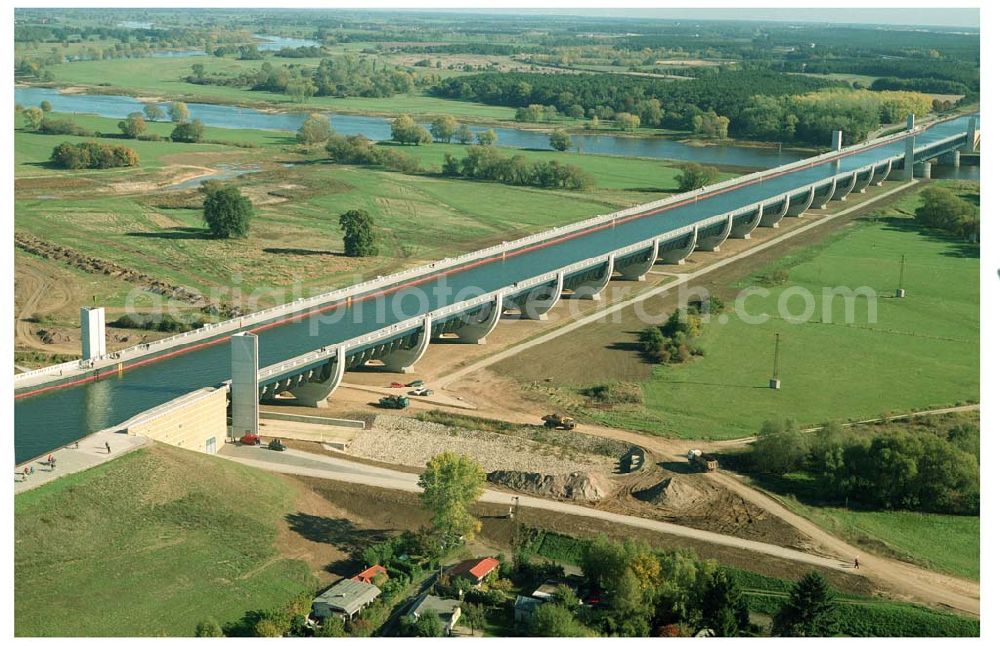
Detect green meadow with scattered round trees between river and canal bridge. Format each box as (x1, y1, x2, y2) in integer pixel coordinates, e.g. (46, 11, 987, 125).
(15, 115, 704, 322)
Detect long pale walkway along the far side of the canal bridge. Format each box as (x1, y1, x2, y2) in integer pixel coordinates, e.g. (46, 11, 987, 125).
(14, 119, 959, 388)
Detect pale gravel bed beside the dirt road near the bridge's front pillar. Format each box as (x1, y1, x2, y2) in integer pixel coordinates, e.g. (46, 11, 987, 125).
(347, 415, 617, 474)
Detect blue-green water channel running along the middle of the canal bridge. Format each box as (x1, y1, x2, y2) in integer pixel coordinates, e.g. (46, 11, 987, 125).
(14, 118, 967, 461)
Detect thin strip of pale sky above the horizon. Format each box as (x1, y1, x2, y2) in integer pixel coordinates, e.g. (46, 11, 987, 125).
(464, 7, 979, 29)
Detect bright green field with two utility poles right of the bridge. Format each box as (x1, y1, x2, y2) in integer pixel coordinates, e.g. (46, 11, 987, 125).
(590, 183, 979, 439)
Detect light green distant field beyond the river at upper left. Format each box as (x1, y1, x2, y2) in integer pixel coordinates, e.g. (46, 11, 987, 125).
(42, 56, 514, 121)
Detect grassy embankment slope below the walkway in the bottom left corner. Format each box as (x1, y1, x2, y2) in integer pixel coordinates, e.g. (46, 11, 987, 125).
(14, 445, 316, 636)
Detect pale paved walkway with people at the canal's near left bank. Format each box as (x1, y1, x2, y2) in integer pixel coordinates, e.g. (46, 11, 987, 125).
(14, 430, 149, 495)
